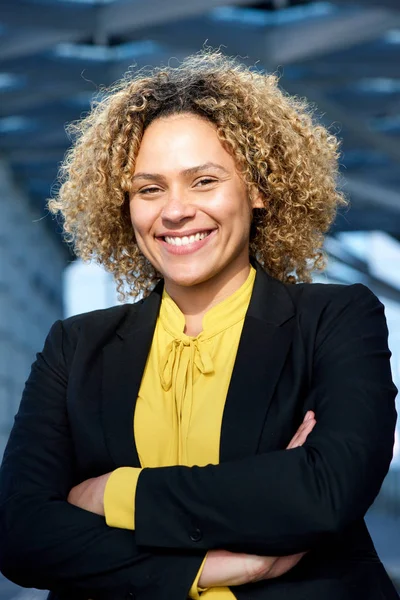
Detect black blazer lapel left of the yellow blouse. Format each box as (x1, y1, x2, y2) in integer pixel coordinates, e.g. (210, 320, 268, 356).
(102, 281, 163, 467)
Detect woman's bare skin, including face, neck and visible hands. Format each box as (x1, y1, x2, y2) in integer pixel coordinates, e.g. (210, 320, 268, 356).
(68, 113, 316, 587)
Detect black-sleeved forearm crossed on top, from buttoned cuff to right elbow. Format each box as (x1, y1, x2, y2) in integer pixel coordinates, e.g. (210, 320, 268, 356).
(136, 424, 389, 556)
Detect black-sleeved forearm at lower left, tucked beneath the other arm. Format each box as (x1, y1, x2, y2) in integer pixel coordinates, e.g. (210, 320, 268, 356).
(0, 495, 204, 600)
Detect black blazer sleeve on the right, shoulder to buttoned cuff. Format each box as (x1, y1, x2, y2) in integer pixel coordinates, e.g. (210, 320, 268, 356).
(135, 284, 397, 556)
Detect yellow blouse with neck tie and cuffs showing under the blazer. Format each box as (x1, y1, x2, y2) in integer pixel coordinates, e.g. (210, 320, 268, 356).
(104, 267, 256, 600)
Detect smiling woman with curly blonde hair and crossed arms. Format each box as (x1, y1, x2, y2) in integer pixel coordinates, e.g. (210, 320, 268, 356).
(0, 52, 397, 600)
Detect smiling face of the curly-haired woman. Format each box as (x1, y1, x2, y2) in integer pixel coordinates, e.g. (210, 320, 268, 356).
(130, 113, 263, 290)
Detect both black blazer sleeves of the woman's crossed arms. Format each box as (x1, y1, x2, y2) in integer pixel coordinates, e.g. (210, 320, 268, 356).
(0, 285, 397, 600)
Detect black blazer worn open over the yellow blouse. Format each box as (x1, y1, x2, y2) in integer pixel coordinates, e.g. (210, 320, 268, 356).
(0, 264, 398, 600)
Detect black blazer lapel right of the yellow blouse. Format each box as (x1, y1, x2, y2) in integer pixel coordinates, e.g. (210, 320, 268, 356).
(220, 263, 295, 462)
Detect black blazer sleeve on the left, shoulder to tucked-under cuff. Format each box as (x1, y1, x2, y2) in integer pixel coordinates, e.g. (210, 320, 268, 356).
(0, 321, 205, 600)
